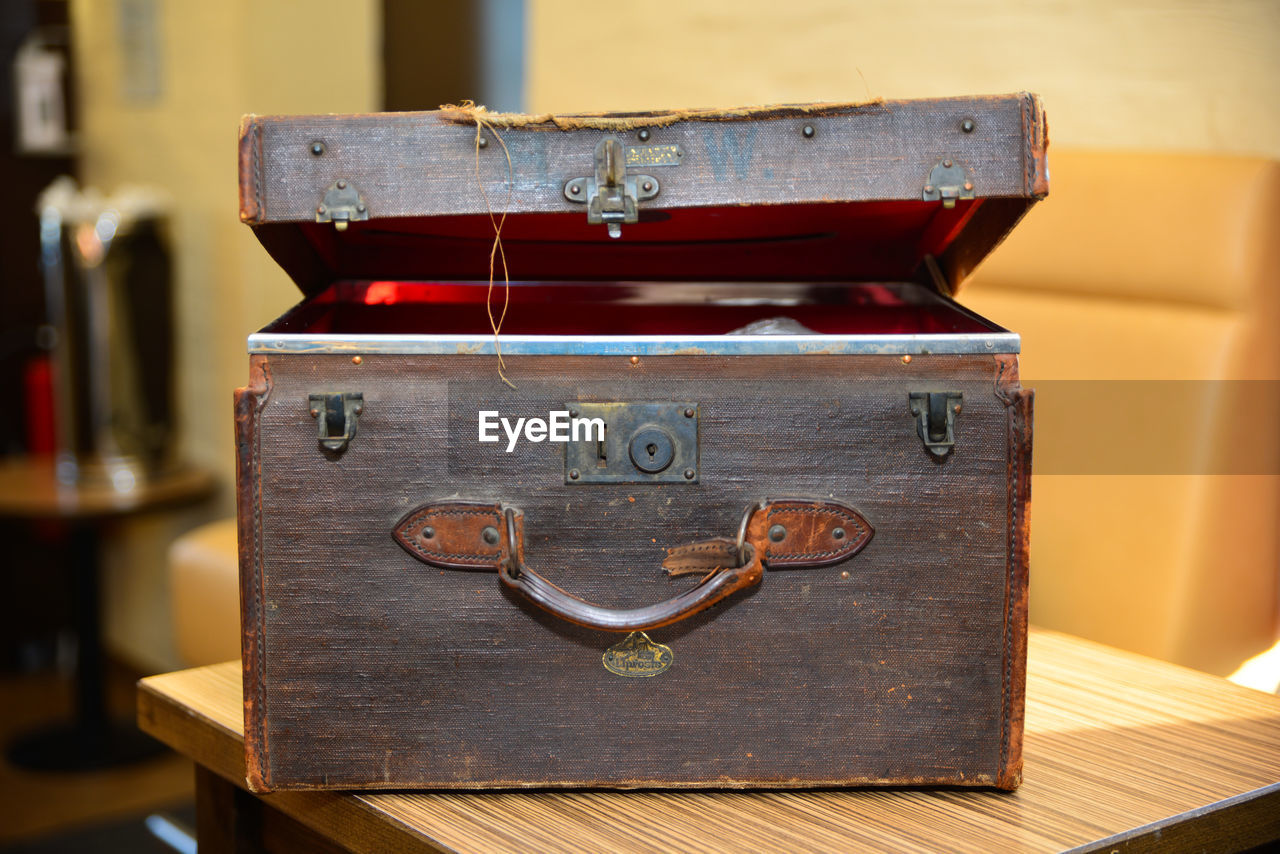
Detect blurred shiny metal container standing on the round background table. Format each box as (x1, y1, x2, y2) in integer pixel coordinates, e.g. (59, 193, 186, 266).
(37, 178, 174, 490)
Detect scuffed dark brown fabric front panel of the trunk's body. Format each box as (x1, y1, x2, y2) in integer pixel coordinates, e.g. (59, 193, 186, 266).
(246, 355, 1025, 787)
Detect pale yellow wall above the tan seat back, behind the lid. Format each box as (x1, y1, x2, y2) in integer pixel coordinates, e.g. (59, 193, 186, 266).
(527, 0, 1280, 156)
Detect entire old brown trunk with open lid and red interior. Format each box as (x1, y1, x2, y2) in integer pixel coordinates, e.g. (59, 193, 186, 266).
(236, 95, 1047, 790)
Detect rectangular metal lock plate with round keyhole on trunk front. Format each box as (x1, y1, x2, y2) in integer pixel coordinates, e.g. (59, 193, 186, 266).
(564, 401, 699, 487)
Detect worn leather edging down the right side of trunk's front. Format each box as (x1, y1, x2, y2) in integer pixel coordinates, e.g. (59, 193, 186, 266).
(996, 384, 1036, 789)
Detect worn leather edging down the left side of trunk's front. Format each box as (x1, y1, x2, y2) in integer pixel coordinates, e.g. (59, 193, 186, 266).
(236, 356, 271, 791)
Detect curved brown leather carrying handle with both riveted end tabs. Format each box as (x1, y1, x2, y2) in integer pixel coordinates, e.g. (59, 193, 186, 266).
(392, 498, 874, 631)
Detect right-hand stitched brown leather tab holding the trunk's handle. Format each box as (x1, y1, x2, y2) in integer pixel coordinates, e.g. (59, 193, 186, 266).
(751, 499, 874, 567)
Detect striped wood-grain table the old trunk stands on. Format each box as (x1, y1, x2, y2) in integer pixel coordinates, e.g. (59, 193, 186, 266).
(138, 631, 1280, 854)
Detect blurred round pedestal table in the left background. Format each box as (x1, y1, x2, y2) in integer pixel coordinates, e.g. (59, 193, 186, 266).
(0, 457, 214, 771)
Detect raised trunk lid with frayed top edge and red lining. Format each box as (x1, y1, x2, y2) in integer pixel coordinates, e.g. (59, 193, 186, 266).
(239, 93, 1048, 294)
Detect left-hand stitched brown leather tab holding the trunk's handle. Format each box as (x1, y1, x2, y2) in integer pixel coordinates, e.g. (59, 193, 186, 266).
(392, 501, 508, 570)
